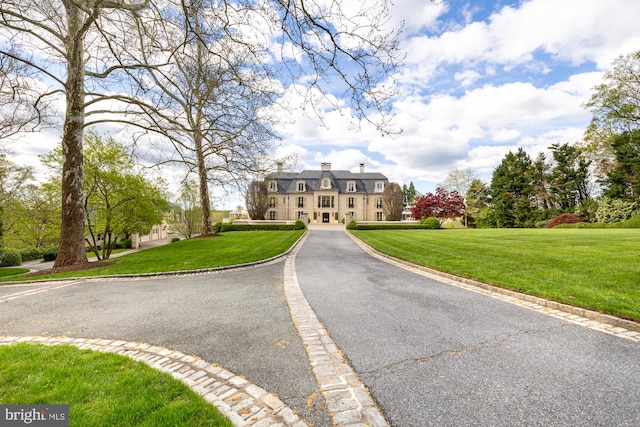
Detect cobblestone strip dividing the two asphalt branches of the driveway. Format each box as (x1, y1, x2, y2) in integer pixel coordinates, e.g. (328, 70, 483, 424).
(284, 236, 389, 427)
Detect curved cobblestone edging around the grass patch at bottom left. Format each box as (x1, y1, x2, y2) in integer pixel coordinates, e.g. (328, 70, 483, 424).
(0, 337, 308, 427)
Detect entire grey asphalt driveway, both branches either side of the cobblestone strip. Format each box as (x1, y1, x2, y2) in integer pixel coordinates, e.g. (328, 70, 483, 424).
(0, 228, 640, 426)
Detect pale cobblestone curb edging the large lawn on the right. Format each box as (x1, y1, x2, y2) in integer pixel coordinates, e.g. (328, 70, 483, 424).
(345, 231, 640, 342)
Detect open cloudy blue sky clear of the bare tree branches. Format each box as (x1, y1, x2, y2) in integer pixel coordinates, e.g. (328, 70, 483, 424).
(12, 0, 640, 208)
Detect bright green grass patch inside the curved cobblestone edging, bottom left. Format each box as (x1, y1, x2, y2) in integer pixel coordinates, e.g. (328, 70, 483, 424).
(0, 344, 233, 427)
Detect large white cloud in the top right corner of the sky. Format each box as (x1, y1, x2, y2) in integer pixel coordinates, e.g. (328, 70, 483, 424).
(403, 0, 640, 85)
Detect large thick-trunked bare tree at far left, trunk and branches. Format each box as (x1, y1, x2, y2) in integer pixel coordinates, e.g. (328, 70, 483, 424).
(0, 0, 148, 267)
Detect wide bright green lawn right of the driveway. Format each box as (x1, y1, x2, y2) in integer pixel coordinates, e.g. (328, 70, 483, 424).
(352, 228, 640, 321)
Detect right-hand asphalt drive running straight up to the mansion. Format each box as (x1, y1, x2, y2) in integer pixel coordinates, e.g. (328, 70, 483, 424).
(296, 231, 640, 426)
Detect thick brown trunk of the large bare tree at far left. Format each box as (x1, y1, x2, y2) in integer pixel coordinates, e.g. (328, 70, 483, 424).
(54, 2, 87, 267)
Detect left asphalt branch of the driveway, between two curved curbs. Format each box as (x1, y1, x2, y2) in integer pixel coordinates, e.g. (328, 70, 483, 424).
(0, 262, 331, 426)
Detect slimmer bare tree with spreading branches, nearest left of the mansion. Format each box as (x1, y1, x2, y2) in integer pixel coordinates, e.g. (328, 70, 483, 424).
(131, 0, 396, 235)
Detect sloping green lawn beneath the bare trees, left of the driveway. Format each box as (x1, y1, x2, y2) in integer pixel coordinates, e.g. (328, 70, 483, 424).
(3, 230, 304, 280)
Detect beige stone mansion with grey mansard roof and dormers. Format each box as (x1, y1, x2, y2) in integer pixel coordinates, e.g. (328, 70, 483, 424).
(265, 163, 389, 224)
